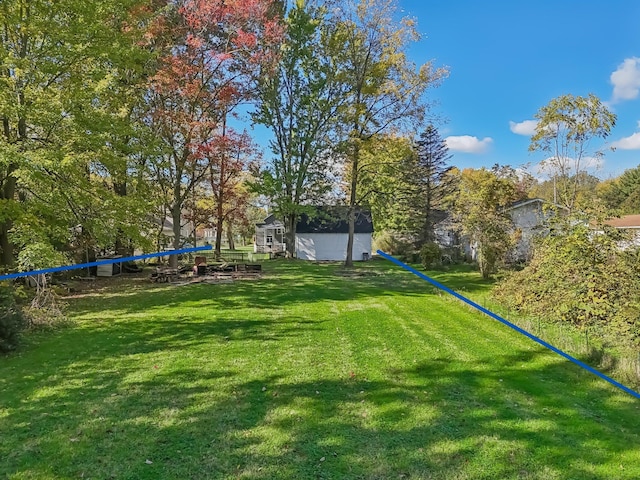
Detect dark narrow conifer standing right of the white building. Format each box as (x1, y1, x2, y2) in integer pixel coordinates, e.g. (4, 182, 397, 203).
(408, 125, 456, 245)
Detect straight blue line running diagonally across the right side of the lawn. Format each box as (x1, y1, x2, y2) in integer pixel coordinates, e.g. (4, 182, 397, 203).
(377, 250, 640, 398)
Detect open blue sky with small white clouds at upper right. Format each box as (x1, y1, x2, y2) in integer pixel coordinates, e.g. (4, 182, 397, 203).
(399, 0, 640, 178)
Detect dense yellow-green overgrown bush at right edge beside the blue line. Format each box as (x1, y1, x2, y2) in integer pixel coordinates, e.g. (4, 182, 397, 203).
(494, 222, 640, 345)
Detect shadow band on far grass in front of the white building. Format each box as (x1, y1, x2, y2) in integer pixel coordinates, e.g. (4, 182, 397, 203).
(65, 260, 490, 315)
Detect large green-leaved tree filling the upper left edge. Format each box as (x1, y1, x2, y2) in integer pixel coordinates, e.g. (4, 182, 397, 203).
(0, 0, 158, 265)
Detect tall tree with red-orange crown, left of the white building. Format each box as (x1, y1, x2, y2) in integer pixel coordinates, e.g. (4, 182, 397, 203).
(149, 0, 279, 266)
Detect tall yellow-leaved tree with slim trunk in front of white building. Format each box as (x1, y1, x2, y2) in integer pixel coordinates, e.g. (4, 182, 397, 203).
(336, 0, 446, 266)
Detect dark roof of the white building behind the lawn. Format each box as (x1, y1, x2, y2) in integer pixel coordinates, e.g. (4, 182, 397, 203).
(296, 206, 373, 233)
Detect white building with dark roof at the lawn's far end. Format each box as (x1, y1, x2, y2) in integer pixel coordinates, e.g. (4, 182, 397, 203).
(295, 207, 373, 261)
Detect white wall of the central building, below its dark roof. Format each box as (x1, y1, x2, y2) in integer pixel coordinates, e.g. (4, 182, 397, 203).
(296, 233, 371, 261)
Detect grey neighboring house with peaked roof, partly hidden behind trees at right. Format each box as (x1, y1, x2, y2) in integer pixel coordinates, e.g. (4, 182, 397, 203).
(506, 198, 564, 261)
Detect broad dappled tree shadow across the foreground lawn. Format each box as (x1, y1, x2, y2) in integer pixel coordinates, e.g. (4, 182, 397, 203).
(0, 351, 640, 479)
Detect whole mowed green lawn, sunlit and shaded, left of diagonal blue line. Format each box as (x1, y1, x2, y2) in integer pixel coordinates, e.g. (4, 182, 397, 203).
(0, 261, 640, 479)
